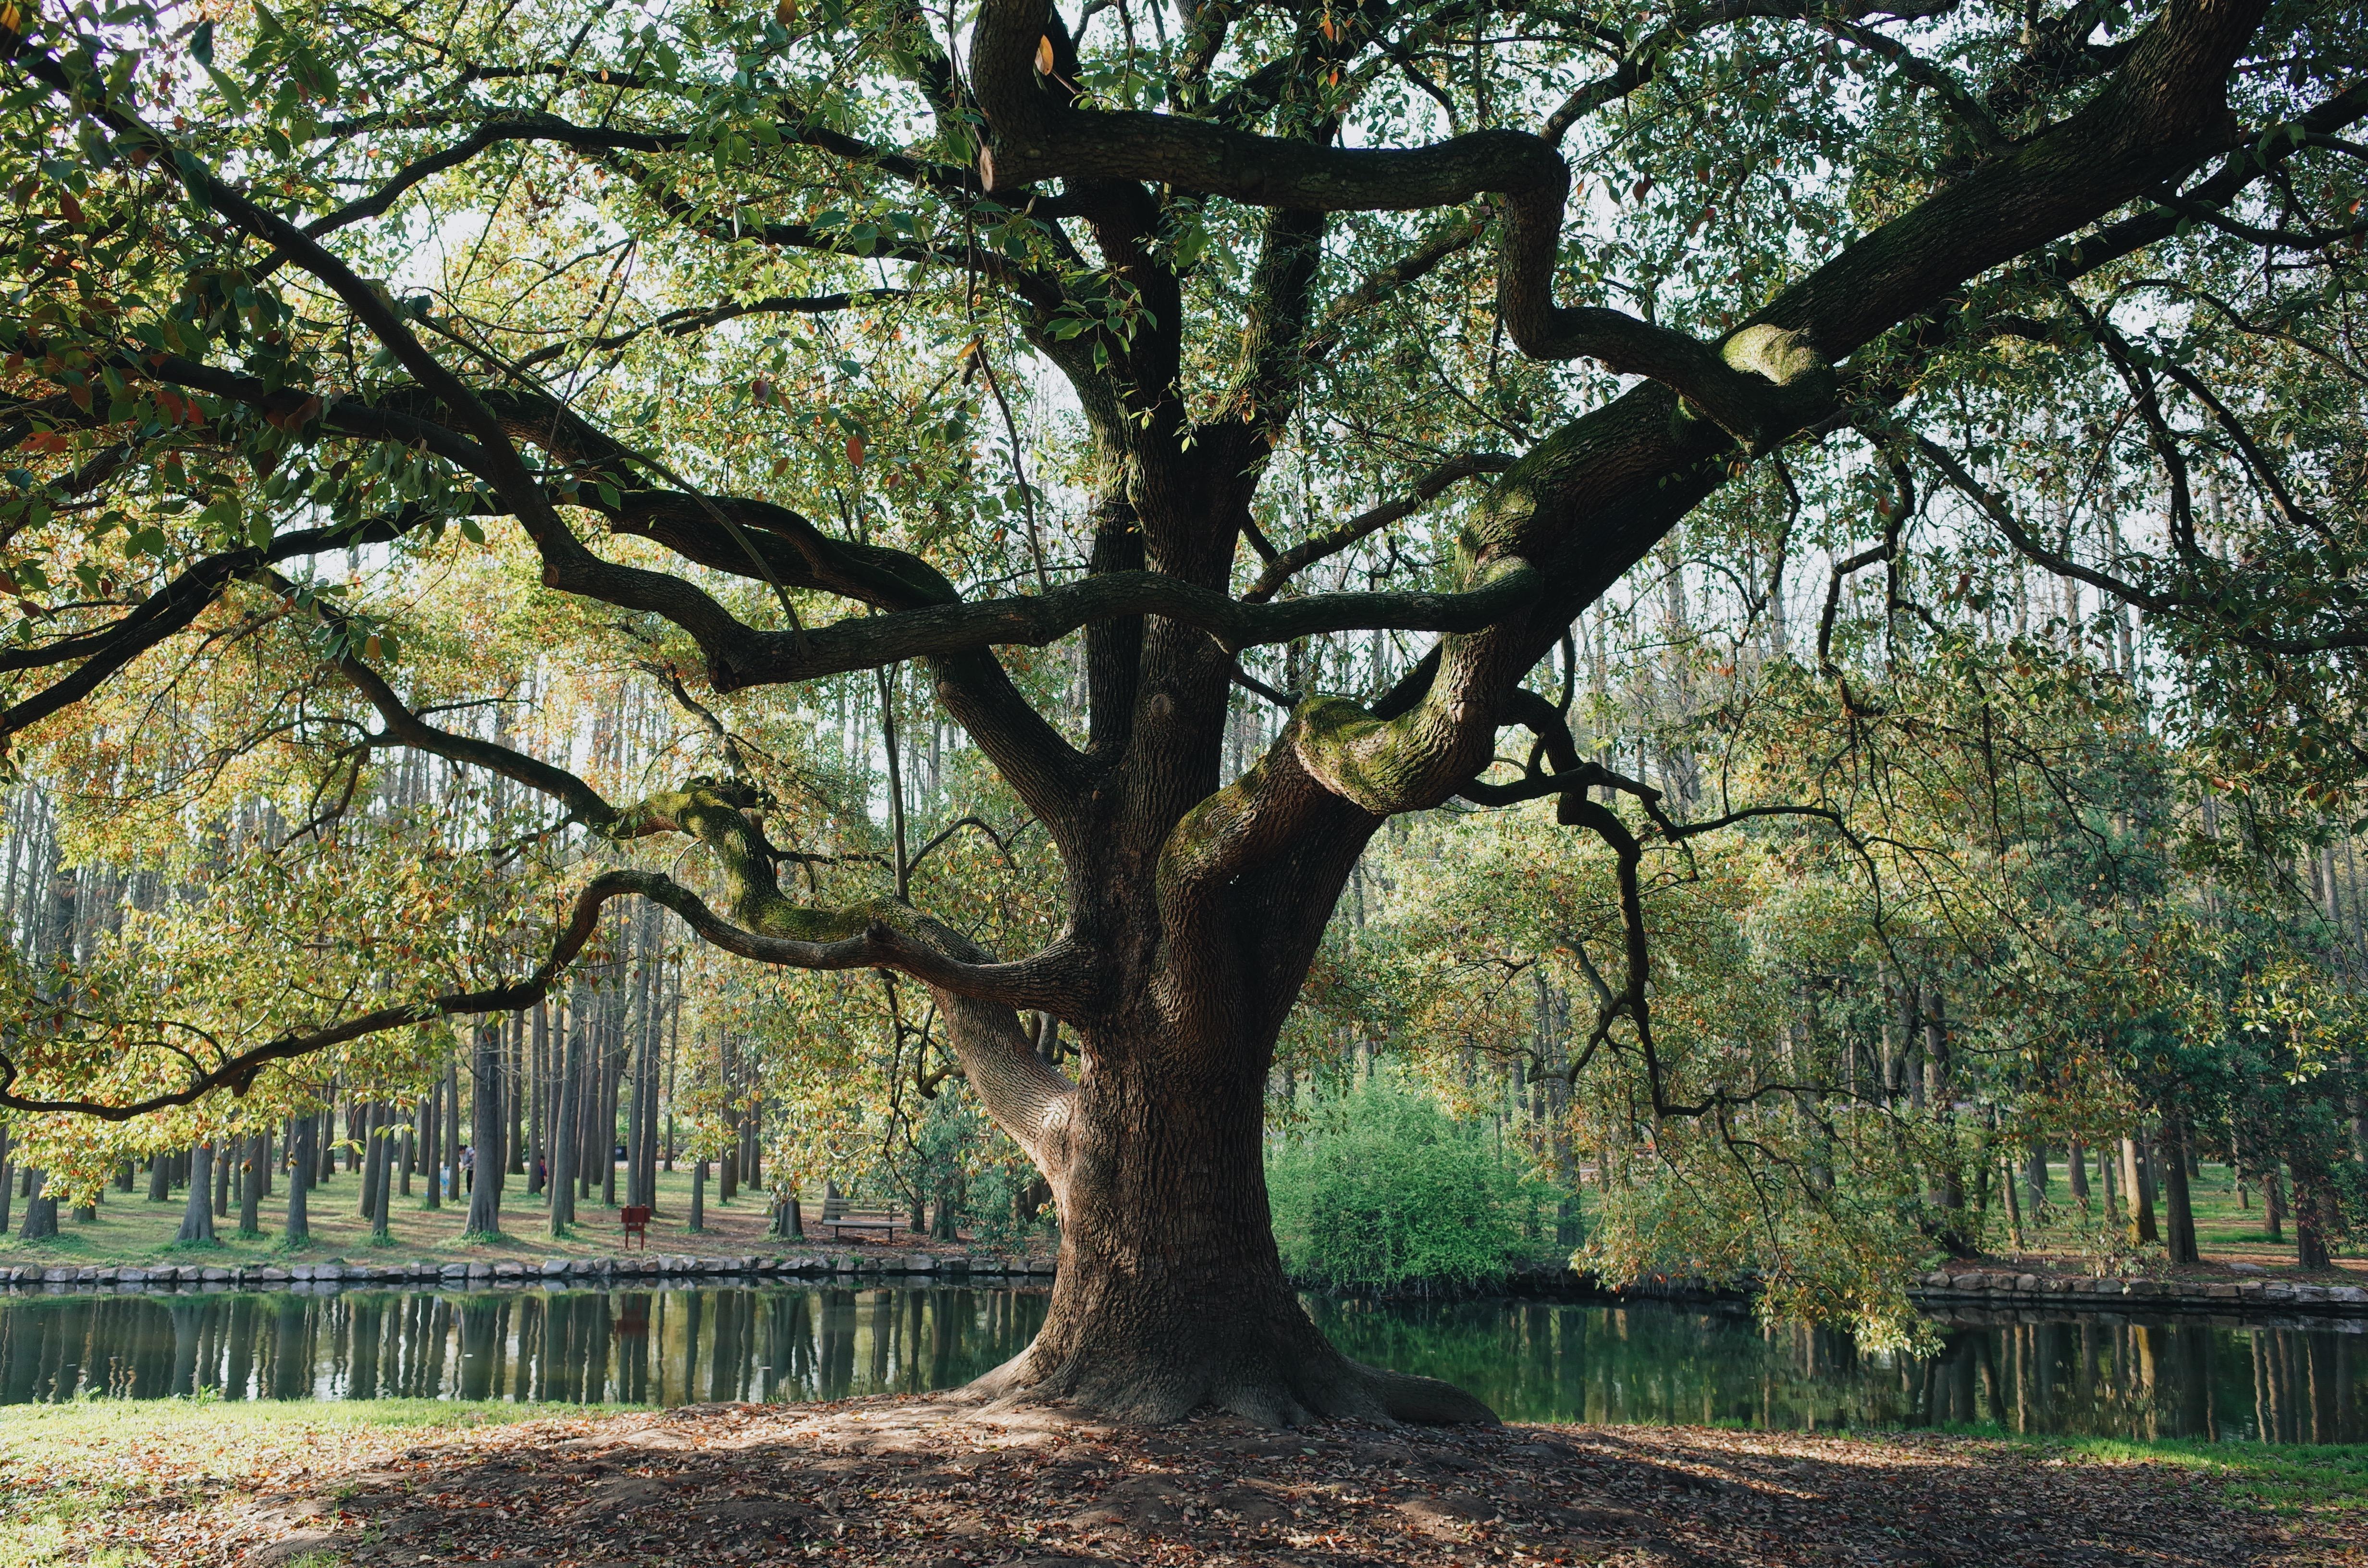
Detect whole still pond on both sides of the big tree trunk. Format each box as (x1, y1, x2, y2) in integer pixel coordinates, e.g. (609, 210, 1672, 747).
(0, 1284, 2368, 1443)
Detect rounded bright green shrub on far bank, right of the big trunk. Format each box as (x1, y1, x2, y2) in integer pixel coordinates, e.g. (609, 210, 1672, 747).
(1267, 1075, 1554, 1291)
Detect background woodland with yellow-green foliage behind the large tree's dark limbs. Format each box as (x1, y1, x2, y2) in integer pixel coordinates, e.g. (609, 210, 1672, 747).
(0, 0, 2368, 1338)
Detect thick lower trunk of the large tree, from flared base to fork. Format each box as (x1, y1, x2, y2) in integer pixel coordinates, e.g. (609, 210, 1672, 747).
(971, 1030, 1494, 1426)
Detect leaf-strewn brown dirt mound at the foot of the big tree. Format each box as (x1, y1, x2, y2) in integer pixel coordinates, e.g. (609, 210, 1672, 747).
(175, 1397, 2368, 1568)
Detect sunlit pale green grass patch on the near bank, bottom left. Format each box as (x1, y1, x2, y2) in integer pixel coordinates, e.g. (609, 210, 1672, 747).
(0, 1397, 623, 1568)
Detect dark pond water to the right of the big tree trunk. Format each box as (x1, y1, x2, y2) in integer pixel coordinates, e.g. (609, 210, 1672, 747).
(1312, 1300, 2368, 1443)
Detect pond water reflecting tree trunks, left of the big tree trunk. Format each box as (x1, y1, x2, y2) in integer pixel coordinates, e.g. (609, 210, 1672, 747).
(0, 1288, 1044, 1405)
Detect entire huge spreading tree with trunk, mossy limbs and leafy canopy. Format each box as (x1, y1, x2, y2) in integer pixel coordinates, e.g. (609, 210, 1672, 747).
(0, 0, 2368, 1419)
